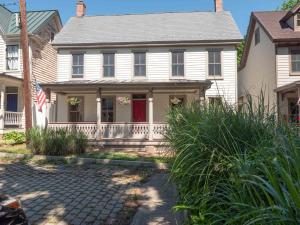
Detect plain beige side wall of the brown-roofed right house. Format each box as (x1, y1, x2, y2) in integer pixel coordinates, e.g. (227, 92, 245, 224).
(238, 24, 277, 106)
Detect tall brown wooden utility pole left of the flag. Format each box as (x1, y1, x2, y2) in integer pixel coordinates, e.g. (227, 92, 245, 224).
(20, 0, 32, 132)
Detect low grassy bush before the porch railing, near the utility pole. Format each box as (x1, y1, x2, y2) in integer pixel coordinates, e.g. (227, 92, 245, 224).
(28, 128, 87, 156)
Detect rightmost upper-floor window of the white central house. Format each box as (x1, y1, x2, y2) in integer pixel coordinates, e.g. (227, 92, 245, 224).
(208, 49, 222, 77)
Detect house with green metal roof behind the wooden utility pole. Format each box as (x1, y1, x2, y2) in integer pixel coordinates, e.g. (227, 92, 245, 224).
(0, 5, 62, 134)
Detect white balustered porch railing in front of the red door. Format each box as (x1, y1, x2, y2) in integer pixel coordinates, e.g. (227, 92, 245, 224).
(48, 123, 167, 140)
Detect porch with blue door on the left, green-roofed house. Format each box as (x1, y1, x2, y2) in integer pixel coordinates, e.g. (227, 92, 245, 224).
(0, 74, 24, 134)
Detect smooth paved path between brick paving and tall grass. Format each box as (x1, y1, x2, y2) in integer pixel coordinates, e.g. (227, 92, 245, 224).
(131, 174, 183, 225)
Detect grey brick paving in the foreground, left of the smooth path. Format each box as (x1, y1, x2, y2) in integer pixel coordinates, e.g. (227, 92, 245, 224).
(0, 162, 144, 225)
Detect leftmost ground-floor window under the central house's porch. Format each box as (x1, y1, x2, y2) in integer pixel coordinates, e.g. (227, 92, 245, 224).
(68, 97, 84, 123)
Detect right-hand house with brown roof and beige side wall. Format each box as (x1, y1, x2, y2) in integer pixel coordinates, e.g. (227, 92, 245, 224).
(238, 3, 300, 122)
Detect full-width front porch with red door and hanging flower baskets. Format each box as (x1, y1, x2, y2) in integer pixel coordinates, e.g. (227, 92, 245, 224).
(43, 81, 211, 142)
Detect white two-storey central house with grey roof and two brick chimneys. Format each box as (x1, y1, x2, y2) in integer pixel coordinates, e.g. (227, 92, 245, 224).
(42, 0, 242, 145)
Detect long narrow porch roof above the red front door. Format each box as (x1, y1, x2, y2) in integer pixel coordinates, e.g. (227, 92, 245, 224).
(41, 80, 212, 92)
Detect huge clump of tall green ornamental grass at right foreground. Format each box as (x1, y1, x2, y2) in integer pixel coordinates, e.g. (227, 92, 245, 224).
(166, 98, 300, 225)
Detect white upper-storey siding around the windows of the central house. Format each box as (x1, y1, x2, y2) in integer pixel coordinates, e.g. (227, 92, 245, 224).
(57, 46, 237, 103)
